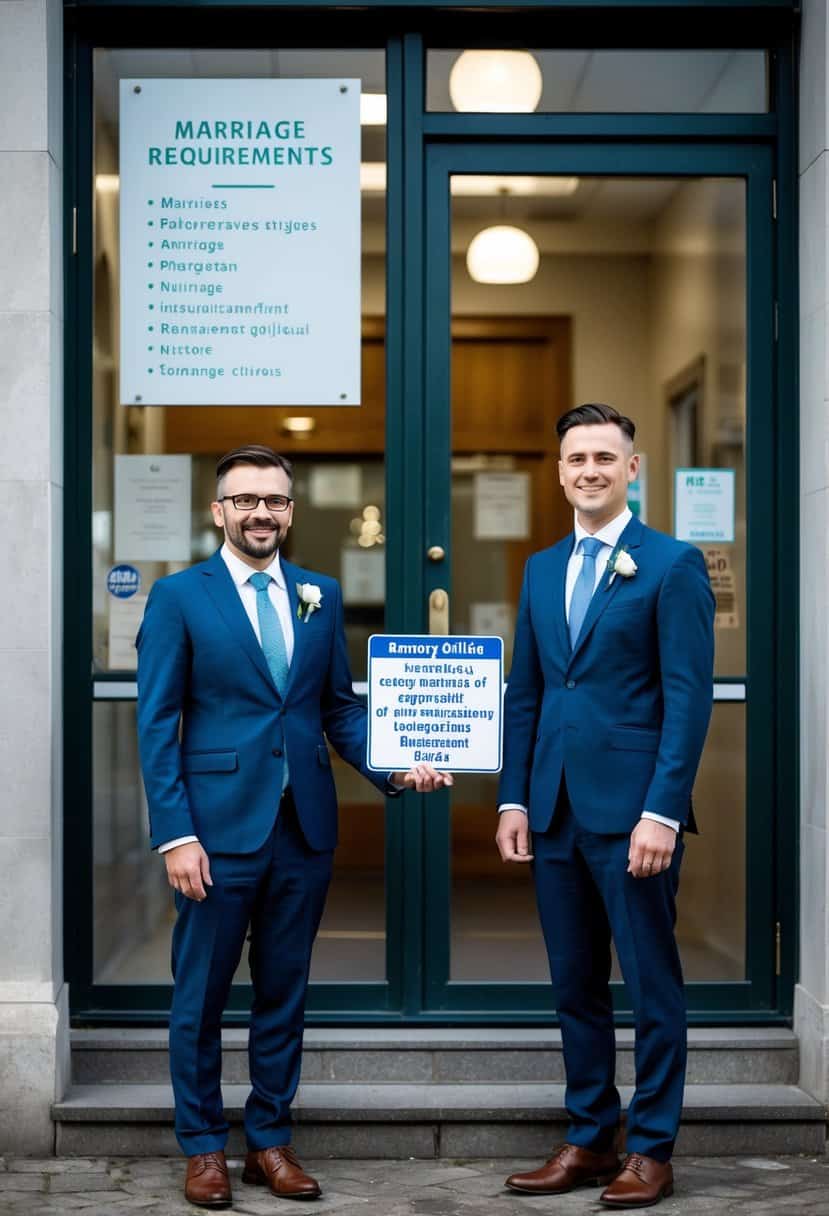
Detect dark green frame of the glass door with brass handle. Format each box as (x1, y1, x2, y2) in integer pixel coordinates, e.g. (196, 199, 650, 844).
(424, 141, 777, 1020)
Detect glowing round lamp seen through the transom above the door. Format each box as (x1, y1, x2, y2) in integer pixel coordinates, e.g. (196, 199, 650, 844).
(449, 51, 543, 114)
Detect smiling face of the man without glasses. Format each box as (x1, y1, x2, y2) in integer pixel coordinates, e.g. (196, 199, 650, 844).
(558, 422, 639, 533)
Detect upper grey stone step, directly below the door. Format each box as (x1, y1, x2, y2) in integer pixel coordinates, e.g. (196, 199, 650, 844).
(72, 1028, 799, 1085)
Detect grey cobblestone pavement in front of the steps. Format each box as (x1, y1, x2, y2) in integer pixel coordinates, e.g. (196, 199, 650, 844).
(0, 1156, 829, 1216)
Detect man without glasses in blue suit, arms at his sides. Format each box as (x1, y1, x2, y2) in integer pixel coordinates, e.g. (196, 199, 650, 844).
(497, 405, 714, 1207)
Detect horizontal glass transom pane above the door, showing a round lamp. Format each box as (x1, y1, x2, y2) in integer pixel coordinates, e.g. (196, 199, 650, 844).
(427, 50, 768, 114)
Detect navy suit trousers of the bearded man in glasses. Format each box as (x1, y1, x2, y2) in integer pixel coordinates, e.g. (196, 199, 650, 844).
(170, 793, 333, 1156)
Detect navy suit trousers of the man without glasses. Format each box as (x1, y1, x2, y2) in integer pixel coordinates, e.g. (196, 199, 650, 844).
(532, 783, 687, 1161)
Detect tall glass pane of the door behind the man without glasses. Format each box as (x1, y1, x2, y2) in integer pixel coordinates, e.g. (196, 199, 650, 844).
(451, 178, 746, 981)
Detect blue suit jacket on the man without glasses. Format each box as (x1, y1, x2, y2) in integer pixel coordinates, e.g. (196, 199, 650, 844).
(498, 518, 714, 833)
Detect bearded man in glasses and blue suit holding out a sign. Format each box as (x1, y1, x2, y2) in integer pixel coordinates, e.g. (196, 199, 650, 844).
(136, 445, 452, 1207)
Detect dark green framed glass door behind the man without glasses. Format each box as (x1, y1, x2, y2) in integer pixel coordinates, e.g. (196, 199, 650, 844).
(424, 143, 774, 1019)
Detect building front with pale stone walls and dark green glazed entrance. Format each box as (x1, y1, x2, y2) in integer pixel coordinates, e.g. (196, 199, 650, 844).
(0, 0, 829, 1153)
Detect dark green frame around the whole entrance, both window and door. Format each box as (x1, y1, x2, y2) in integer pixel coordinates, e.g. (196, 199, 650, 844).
(64, 7, 799, 1025)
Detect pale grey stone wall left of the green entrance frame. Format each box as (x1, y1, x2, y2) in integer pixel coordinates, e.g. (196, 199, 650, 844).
(0, 0, 68, 1154)
